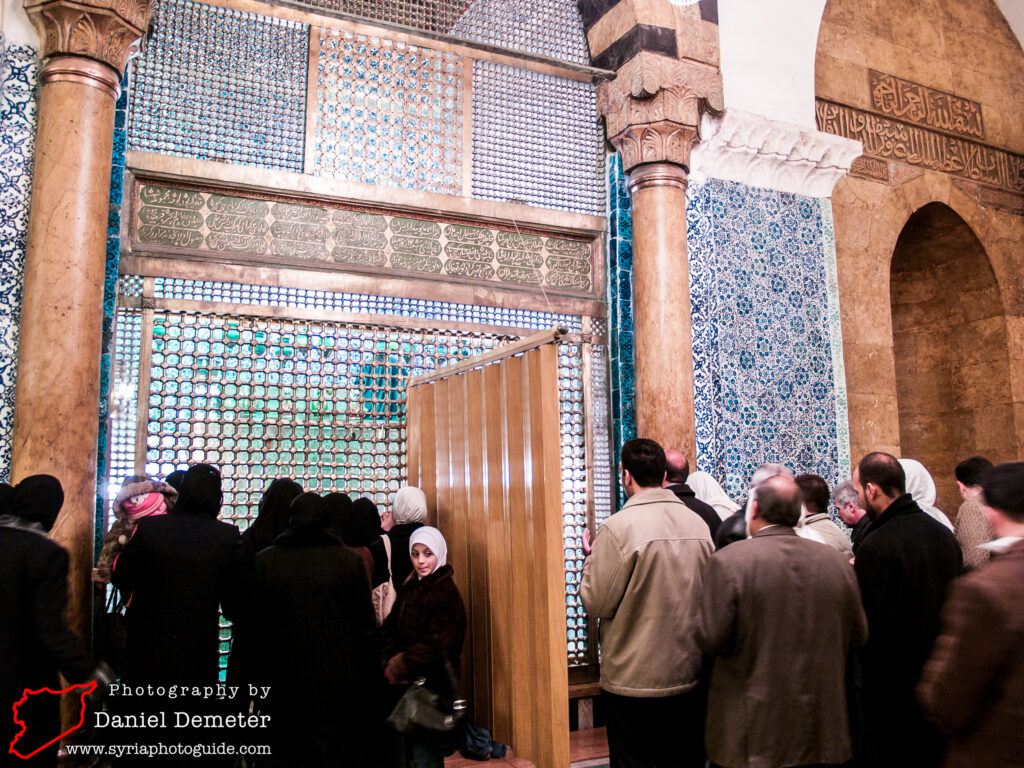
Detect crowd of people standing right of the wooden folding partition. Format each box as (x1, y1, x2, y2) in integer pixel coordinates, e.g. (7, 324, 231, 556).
(580, 439, 1024, 768)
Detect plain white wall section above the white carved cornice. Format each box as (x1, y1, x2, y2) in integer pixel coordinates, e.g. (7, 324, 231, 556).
(718, 0, 827, 129)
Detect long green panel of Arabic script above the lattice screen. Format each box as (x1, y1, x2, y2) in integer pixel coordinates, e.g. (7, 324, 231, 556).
(131, 181, 594, 293)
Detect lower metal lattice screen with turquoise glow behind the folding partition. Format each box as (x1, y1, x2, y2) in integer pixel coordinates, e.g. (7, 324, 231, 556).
(110, 276, 610, 665)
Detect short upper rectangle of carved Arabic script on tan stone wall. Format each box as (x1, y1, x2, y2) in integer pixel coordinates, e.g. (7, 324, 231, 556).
(867, 70, 985, 138)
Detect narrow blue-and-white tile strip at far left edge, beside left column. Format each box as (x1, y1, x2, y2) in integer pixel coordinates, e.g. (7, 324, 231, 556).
(0, 39, 39, 480)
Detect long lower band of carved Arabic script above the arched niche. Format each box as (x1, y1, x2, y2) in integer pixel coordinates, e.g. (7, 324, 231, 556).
(815, 99, 1024, 191)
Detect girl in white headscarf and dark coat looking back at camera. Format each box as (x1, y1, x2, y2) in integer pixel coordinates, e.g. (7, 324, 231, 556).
(381, 525, 466, 768)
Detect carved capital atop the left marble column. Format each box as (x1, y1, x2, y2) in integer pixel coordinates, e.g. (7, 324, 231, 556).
(25, 0, 151, 76)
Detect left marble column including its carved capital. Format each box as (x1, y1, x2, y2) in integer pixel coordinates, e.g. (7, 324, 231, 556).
(11, 0, 150, 638)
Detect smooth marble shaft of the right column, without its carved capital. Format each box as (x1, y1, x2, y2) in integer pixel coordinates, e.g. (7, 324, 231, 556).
(629, 163, 696, 461)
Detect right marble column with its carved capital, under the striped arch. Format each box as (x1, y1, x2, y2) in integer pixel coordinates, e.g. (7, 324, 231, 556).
(597, 51, 722, 466)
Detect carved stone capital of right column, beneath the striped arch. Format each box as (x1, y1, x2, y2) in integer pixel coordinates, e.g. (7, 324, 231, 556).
(597, 51, 723, 173)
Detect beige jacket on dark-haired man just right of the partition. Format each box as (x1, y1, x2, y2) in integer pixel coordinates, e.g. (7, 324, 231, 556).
(580, 488, 715, 697)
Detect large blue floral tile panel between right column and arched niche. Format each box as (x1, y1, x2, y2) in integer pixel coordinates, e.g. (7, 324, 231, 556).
(687, 179, 849, 498)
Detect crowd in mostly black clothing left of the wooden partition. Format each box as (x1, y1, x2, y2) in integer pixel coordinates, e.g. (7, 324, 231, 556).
(0, 464, 466, 768)
